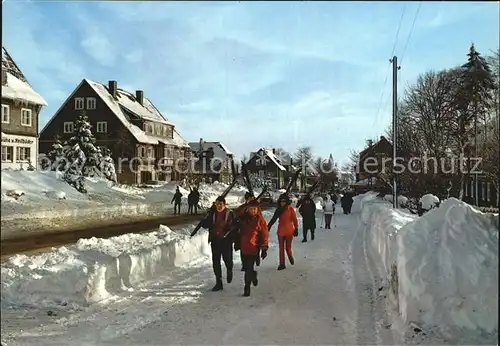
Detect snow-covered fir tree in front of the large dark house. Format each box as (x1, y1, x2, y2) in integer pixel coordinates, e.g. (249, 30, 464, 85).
(47, 112, 117, 193)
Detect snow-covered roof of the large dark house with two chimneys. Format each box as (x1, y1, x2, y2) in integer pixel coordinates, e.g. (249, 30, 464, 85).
(85, 79, 189, 148)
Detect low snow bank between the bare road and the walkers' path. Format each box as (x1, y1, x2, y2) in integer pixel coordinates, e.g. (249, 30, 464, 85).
(1, 226, 210, 306)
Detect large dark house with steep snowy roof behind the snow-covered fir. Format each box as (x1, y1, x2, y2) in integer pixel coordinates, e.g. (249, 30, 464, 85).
(39, 79, 191, 184)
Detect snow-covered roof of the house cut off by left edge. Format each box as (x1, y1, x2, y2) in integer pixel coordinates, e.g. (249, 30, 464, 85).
(2, 47, 47, 106)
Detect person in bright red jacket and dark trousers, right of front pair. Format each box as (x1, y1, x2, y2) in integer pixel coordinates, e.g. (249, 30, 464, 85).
(240, 200, 269, 297)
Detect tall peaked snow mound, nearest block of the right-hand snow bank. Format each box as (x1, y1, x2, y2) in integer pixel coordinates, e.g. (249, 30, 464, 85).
(398, 198, 498, 333)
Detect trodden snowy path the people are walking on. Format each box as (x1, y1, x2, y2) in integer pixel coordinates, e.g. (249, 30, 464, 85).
(2, 213, 394, 345)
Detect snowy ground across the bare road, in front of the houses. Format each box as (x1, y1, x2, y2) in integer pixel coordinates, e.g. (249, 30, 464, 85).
(1, 170, 254, 238)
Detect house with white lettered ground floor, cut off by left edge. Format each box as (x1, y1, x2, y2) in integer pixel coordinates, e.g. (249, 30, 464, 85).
(1, 47, 47, 169)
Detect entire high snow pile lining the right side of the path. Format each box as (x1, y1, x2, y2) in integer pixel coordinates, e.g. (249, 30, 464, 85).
(358, 194, 499, 340)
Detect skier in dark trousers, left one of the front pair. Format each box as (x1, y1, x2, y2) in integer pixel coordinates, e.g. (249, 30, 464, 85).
(202, 196, 234, 292)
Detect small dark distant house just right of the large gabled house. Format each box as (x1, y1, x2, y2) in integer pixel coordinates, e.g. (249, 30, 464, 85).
(189, 138, 234, 184)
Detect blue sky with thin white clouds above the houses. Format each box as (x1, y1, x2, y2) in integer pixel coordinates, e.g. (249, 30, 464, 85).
(2, 0, 499, 162)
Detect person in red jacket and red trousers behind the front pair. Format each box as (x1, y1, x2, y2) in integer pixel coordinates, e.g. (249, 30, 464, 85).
(267, 194, 299, 270)
